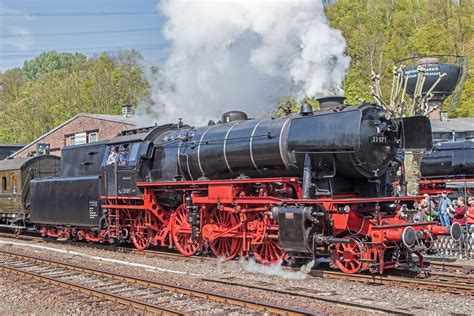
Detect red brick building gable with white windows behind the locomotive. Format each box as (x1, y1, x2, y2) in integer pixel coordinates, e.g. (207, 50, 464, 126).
(10, 113, 136, 158)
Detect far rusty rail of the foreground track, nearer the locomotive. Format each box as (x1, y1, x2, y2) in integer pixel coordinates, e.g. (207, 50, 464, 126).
(0, 250, 310, 315)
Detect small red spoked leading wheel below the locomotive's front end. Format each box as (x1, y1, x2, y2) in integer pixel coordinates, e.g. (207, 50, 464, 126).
(334, 237, 365, 274)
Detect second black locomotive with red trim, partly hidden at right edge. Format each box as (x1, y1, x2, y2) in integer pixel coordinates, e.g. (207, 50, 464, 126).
(420, 140, 474, 195)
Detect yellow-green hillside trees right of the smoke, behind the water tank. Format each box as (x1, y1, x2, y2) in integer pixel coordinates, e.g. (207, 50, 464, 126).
(326, 0, 474, 116)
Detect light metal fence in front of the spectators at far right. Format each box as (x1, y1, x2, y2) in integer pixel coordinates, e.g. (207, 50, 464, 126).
(433, 227, 474, 260)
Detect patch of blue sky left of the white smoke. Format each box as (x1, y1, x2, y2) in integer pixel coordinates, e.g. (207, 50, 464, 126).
(0, 0, 169, 71)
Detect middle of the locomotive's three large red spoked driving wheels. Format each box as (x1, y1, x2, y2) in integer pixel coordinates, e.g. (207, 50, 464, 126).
(209, 208, 242, 260)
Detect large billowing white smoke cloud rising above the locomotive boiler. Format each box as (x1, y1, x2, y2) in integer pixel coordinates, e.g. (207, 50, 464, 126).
(146, 0, 350, 125)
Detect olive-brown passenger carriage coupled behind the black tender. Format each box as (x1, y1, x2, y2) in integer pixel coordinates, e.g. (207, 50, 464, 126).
(0, 155, 60, 228)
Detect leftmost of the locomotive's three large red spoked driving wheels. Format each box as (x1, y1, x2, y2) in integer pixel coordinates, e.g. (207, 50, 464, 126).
(171, 205, 201, 256)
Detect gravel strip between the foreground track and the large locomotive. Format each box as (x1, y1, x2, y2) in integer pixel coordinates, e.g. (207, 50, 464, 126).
(0, 238, 474, 315)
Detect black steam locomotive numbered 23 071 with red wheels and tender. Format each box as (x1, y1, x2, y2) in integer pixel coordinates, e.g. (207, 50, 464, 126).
(6, 98, 461, 273)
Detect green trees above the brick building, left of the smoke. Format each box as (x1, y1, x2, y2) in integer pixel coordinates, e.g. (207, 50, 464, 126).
(0, 52, 149, 143)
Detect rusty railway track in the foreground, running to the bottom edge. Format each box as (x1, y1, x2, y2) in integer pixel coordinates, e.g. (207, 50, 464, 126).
(0, 251, 309, 315)
